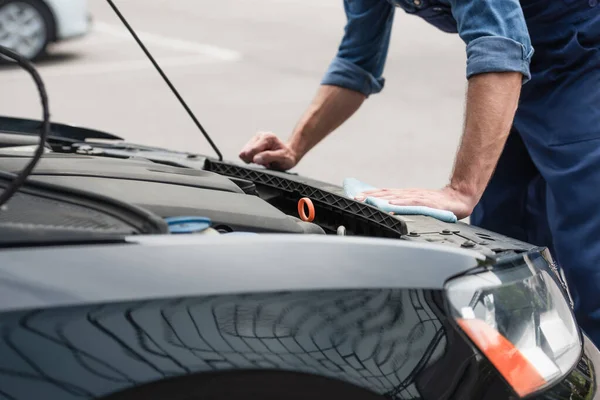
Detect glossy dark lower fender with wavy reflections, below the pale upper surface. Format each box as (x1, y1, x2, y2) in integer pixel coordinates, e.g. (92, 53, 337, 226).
(0, 289, 595, 400)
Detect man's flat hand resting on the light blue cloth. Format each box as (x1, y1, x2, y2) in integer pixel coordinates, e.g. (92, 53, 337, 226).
(355, 186, 477, 219)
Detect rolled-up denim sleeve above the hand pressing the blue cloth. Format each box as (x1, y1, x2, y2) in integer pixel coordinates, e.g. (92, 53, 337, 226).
(450, 0, 534, 83)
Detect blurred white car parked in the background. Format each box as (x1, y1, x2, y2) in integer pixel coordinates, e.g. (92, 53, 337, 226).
(0, 0, 91, 60)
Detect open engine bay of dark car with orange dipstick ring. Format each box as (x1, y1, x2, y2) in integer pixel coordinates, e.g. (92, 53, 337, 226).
(0, 133, 534, 256)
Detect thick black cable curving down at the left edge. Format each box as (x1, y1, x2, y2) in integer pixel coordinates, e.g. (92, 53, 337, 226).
(0, 46, 50, 211)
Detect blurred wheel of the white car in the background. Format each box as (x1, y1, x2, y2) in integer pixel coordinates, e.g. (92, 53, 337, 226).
(0, 0, 55, 61)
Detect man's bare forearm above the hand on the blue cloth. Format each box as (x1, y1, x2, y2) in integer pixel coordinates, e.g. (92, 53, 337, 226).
(450, 72, 522, 207)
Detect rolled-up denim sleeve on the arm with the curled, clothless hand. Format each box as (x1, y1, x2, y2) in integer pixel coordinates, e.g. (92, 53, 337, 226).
(321, 0, 395, 97)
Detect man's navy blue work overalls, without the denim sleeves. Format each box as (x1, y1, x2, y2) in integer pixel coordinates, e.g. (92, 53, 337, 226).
(471, 0, 600, 346)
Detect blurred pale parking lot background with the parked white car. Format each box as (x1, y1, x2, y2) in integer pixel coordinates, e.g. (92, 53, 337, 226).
(0, 0, 466, 188)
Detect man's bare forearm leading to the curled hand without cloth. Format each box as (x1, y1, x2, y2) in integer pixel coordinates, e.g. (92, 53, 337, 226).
(288, 85, 366, 161)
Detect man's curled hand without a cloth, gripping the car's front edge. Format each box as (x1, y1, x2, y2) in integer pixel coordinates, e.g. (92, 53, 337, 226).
(239, 132, 298, 171)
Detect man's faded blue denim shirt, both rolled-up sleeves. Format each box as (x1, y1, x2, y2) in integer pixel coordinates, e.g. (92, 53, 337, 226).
(321, 0, 533, 96)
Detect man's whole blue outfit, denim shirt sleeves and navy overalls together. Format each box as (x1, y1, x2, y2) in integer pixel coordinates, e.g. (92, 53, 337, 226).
(322, 0, 600, 346)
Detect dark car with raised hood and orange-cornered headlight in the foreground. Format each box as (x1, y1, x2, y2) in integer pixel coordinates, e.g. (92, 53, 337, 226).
(0, 1, 600, 400)
